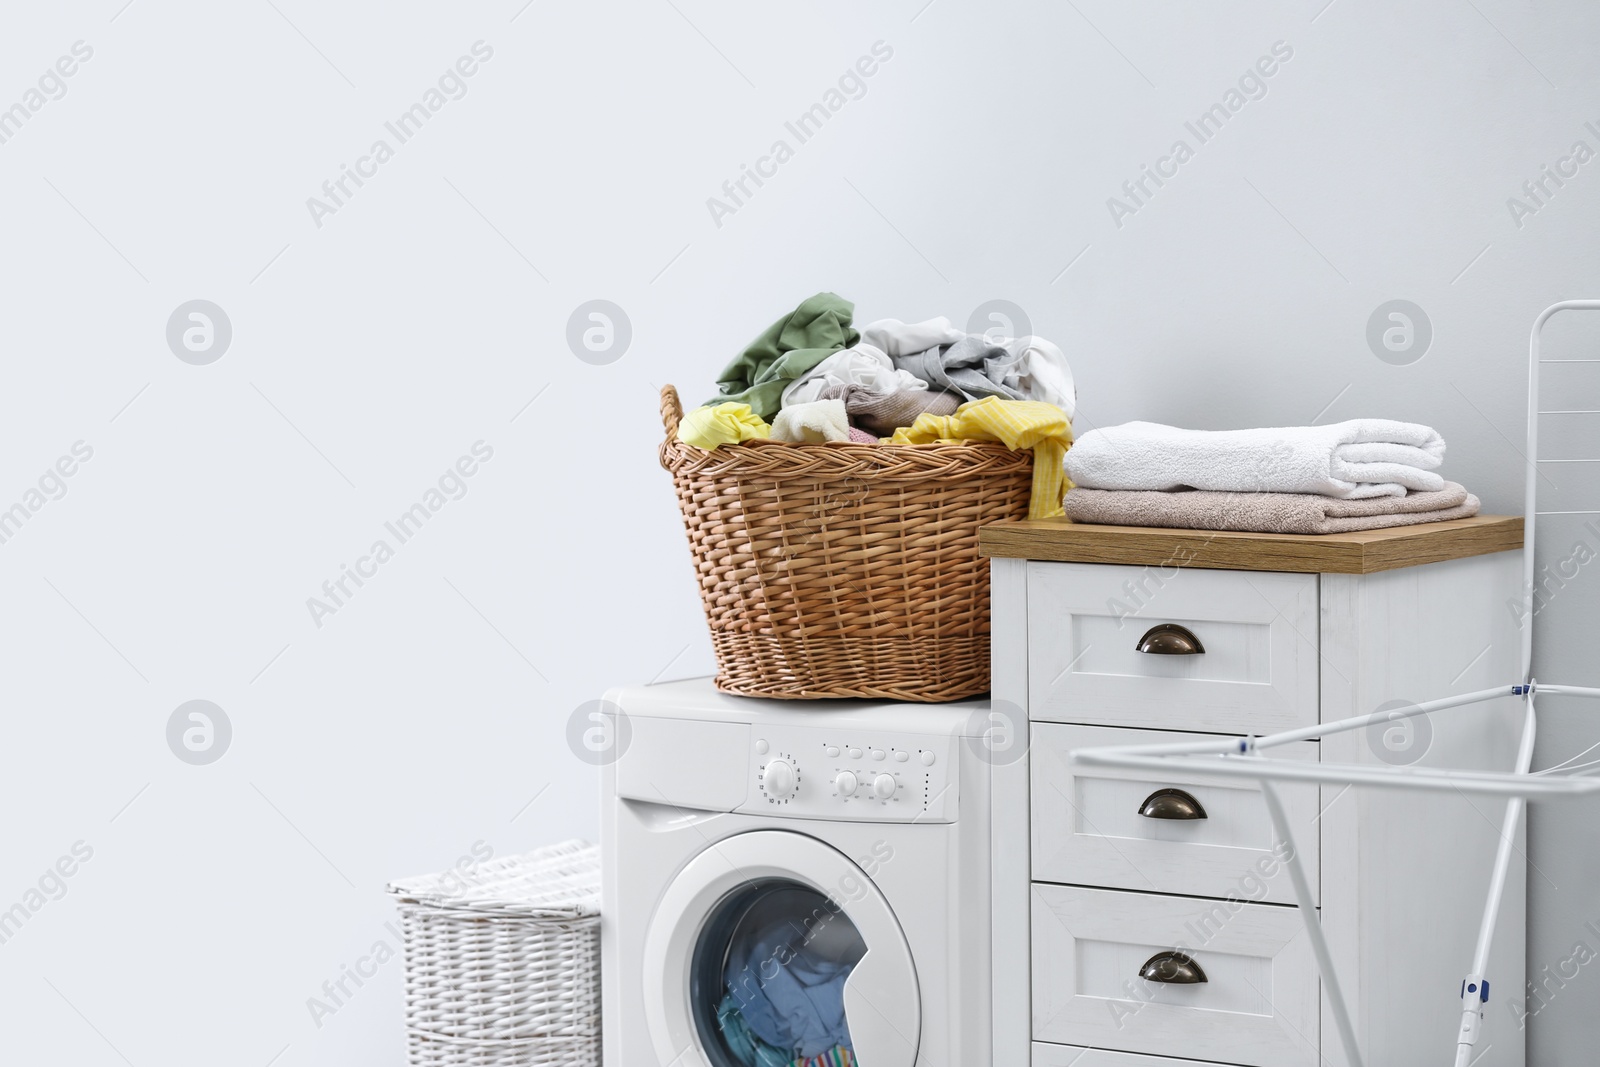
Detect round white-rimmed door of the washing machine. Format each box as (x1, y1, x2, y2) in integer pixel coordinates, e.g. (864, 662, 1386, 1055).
(643, 830, 922, 1067)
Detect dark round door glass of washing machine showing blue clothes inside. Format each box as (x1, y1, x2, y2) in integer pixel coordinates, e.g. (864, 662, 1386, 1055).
(690, 878, 867, 1067)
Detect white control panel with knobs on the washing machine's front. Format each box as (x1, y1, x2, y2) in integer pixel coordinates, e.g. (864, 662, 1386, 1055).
(741, 723, 962, 822)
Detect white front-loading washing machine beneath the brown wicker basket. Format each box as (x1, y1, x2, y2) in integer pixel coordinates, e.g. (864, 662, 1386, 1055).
(597, 678, 992, 1067)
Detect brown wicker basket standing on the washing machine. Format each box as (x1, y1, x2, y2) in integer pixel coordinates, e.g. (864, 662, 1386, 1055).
(661, 386, 1034, 701)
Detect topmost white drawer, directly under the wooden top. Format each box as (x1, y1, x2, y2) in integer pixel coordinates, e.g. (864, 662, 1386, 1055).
(1027, 561, 1320, 734)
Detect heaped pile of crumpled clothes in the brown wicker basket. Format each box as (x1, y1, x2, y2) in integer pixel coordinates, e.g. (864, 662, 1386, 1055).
(678, 293, 1077, 518)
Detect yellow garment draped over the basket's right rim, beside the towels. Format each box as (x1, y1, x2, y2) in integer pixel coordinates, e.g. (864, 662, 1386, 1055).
(890, 397, 1072, 518)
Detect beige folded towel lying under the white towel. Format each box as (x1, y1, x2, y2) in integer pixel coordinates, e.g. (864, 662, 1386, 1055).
(1064, 482, 1480, 534)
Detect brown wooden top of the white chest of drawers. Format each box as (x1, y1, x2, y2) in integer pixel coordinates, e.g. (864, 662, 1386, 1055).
(979, 515, 1522, 574)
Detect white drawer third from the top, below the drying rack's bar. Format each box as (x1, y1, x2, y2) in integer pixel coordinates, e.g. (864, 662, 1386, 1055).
(1032, 885, 1320, 1067)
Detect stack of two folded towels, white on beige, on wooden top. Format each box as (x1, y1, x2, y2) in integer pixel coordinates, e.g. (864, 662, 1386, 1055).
(1066, 419, 1480, 534)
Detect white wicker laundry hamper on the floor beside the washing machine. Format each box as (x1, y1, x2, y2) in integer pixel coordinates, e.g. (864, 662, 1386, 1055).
(389, 841, 600, 1067)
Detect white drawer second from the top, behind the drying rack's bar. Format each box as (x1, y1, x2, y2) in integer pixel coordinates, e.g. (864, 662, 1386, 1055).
(1030, 723, 1322, 904)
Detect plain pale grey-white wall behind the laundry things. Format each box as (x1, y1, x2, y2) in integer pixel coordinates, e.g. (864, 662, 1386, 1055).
(0, 0, 1600, 1067)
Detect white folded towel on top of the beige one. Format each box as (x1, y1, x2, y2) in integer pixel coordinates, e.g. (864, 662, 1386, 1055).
(1066, 419, 1445, 501)
